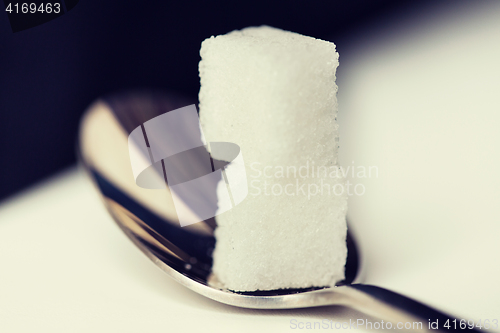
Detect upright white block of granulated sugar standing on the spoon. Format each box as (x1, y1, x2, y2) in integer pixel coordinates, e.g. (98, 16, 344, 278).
(199, 26, 347, 291)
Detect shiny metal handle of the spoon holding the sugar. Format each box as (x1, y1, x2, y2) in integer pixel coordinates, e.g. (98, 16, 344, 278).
(344, 284, 485, 332)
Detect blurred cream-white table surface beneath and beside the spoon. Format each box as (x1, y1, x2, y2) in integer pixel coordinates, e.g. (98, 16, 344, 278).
(0, 1, 500, 332)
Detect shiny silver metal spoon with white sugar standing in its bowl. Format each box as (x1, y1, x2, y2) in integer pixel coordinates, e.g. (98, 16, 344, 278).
(78, 92, 484, 331)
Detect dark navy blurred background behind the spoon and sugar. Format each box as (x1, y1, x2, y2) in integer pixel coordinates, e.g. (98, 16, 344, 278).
(0, 0, 458, 199)
